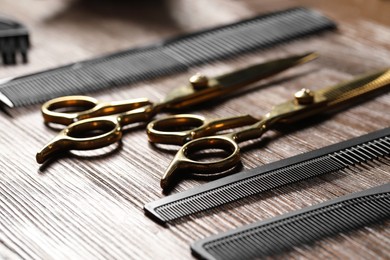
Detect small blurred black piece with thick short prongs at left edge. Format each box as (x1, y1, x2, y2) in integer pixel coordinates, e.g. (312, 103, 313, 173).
(0, 17, 30, 65)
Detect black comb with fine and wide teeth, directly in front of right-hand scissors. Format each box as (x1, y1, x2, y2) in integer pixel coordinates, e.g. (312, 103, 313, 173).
(144, 128, 390, 224)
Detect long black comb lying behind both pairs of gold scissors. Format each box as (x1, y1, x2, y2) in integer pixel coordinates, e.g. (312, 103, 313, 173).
(0, 8, 336, 107)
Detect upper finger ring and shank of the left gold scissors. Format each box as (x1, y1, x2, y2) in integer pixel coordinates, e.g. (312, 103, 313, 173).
(41, 96, 151, 125)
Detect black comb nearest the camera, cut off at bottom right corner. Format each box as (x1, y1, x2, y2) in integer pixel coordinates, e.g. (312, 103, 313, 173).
(191, 183, 390, 259)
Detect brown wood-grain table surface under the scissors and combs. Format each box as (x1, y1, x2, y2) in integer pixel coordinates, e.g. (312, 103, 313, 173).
(0, 0, 390, 259)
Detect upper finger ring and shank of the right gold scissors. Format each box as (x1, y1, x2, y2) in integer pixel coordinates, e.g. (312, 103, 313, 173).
(146, 114, 258, 145)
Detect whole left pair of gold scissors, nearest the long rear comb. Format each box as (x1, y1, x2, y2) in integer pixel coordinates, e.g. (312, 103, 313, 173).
(36, 53, 317, 163)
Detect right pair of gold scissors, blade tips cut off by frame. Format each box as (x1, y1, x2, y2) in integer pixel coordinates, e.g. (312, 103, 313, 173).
(147, 69, 390, 189)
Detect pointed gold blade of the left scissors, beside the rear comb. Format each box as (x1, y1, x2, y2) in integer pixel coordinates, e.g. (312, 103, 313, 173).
(162, 52, 318, 109)
